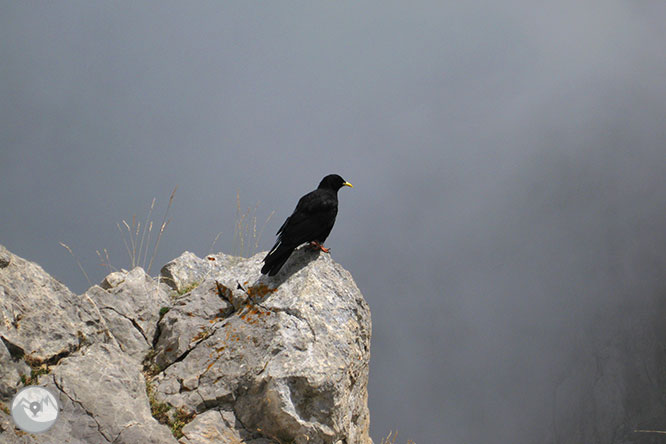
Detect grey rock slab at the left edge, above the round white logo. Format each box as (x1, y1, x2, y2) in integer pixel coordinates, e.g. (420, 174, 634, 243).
(0, 245, 104, 363)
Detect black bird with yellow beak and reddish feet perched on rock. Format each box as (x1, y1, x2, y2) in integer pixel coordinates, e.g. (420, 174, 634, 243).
(261, 174, 353, 276)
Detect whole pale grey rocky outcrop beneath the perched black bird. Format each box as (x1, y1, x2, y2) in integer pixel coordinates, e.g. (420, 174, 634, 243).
(0, 247, 372, 444)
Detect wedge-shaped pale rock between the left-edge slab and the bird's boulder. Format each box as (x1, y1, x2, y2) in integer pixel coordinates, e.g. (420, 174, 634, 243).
(85, 267, 170, 361)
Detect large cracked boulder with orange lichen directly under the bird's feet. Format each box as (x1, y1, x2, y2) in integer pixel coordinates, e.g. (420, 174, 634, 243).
(153, 249, 371, 444)
